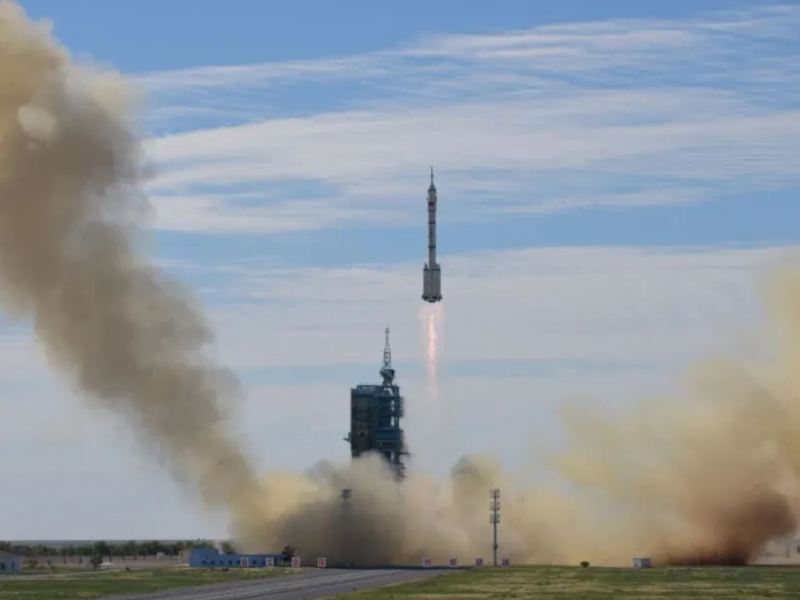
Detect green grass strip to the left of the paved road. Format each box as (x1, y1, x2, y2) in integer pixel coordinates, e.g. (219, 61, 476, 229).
(0, 568, 292, 600)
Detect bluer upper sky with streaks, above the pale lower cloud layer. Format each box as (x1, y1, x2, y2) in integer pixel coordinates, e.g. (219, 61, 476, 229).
(24, 1, 800, 265)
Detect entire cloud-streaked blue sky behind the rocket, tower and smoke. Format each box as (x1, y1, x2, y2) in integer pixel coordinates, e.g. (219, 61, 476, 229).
(0, 0, 800, 538)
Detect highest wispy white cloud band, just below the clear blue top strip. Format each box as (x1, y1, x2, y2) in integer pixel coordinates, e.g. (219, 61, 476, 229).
(137, 5, 800, 92)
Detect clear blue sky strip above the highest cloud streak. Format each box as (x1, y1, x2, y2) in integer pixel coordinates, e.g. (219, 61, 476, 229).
(22, 0, 763, 72)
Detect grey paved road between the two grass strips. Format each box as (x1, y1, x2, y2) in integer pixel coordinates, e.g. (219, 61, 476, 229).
(109, 569, 445, 600)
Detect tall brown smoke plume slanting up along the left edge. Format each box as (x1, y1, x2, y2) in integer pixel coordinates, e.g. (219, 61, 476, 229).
(0, 2, 256, 524)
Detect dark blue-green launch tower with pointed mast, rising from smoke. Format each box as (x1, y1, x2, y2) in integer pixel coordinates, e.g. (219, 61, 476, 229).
(345, 328, 408, 477)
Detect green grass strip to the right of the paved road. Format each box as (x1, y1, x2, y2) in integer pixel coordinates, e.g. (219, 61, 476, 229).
(343, 567, 800, 600)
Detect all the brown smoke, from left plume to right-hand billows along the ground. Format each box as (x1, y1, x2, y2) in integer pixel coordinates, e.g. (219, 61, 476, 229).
(0, 2, 800, 564)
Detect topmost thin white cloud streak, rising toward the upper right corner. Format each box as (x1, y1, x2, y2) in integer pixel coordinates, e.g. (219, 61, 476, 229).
(136, 5, 800, 92)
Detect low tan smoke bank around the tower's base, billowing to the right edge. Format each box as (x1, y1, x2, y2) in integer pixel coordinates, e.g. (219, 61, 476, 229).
(242, 269, 800, 565)
